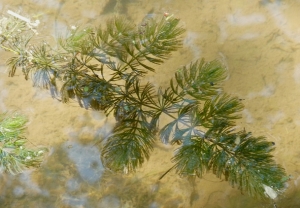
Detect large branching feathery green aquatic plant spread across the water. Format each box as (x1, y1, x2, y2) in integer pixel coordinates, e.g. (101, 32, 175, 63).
(0, 12, 286, 199)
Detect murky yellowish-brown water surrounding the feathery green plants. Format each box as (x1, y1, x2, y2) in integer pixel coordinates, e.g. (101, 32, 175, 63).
(0, 0, 300, 208)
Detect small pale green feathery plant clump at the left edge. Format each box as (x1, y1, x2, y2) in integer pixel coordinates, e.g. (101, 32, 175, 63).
(0, 113, 45, 174)
